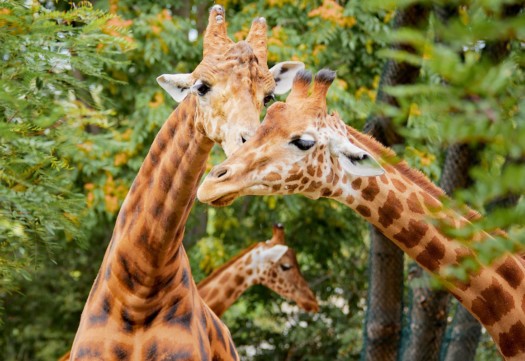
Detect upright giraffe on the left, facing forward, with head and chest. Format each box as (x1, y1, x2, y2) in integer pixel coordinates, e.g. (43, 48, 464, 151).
(70, 5, 304, 360)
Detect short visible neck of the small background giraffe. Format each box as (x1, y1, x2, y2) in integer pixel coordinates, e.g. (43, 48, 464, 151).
(197, 243, 261, 317)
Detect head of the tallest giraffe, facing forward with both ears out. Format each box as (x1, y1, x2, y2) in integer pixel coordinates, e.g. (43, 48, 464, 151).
(157, 5, 304, 155)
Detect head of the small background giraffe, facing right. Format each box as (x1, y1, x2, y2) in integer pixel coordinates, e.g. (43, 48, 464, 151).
(253, 224, 319, 312)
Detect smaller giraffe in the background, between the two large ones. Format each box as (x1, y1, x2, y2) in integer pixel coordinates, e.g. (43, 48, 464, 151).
(197, 224, 319, 317)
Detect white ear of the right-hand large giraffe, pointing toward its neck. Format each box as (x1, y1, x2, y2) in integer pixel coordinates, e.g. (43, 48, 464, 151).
(330, 139, 385, 177)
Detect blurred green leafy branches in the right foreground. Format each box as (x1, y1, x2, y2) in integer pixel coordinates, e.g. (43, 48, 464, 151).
(376, 1, 525, 264)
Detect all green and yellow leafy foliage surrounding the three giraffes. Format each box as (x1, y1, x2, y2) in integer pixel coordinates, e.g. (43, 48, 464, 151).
(0, 0, 525, 361)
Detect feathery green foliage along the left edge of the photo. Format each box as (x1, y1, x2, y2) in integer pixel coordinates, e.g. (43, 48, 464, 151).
(0, 2, 128, 310)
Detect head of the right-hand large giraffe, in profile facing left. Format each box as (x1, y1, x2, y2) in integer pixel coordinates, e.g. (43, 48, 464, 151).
(197, 70, 384, 206)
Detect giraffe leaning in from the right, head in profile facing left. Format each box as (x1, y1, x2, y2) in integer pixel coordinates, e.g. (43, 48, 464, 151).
(198, 70, 525, 361)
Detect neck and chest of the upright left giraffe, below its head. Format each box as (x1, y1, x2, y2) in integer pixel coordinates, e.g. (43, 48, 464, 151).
(72, 96, 238, 360)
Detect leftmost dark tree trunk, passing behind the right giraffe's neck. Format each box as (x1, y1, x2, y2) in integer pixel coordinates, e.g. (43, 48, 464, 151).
(362, 5, 428, 361)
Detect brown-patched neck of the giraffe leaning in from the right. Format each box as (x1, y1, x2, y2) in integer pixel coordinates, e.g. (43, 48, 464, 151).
(331, 123, 525, 360)
